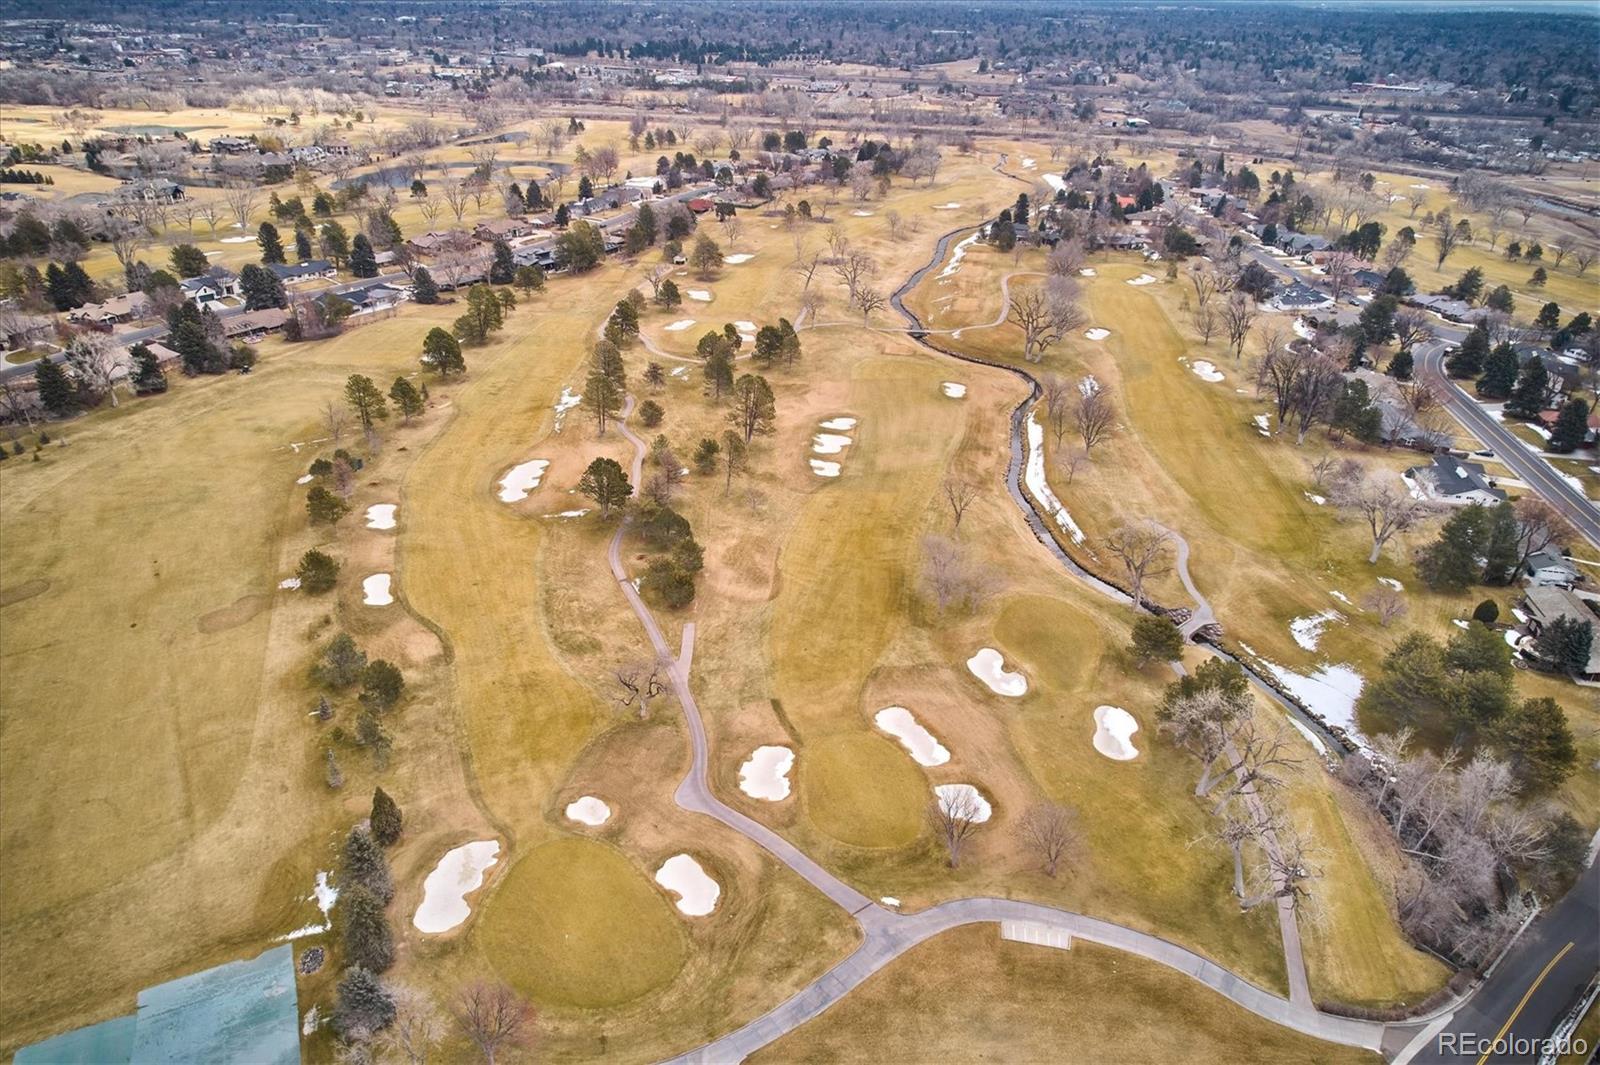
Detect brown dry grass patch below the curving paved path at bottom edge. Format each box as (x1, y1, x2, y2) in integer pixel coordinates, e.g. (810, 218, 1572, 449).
(752, 924, 1378, 1063)
